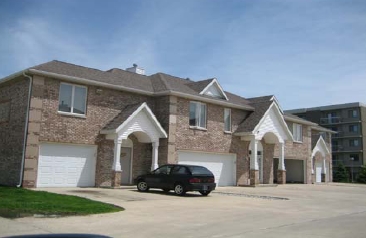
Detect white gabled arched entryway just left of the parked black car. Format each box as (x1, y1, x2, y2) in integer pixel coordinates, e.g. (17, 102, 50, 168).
(101, 103, 167, 187)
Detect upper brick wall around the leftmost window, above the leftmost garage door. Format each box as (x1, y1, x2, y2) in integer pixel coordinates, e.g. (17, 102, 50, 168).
(39, 79, 154, 144)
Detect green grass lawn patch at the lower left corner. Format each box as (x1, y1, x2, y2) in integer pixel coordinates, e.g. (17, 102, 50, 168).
(0, 186, 124, 217)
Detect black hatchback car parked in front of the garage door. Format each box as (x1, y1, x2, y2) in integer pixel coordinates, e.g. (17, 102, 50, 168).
(135, 164, 216, 196)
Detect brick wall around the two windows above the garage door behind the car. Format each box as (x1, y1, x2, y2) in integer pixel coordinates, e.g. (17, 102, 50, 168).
(175, 98, 249, 184)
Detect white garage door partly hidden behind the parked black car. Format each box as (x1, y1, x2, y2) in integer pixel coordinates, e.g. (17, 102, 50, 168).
(178, 151, 236, 186)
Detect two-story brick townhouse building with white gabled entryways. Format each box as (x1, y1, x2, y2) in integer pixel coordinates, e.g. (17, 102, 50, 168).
(0, 61, 332, 187)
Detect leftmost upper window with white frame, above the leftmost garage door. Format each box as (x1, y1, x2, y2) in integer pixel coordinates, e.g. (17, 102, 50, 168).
(58, 83, 86, 114)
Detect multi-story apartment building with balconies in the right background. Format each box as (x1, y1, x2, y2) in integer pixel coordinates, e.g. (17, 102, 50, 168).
(286, 102, 366, 180)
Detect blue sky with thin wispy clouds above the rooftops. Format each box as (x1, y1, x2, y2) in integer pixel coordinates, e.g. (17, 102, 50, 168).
(0, 0, 366, 109)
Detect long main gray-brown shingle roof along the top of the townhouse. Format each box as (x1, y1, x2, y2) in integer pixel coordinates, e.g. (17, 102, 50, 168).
(30, 60, 251, 109)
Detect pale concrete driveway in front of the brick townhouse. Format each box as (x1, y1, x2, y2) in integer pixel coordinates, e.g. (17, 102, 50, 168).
(0, 184, 366, 238)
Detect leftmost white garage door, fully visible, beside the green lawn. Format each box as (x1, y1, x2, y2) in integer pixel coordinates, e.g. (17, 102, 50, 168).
(37, 144, 96, 187)
